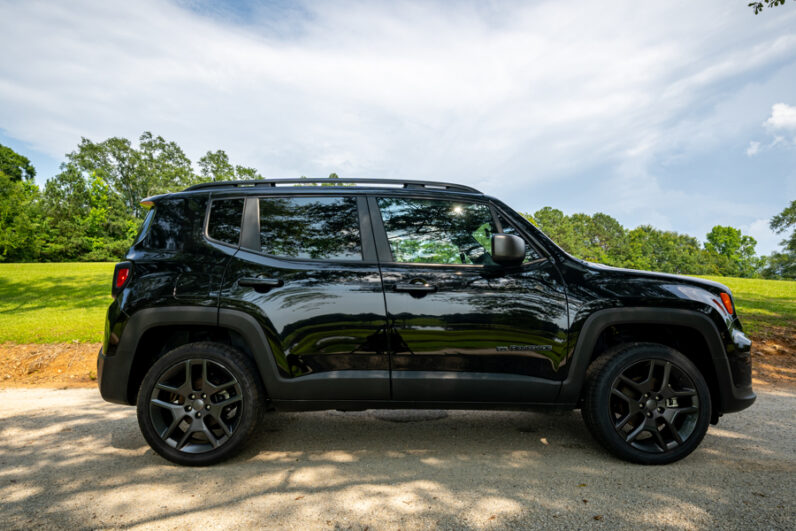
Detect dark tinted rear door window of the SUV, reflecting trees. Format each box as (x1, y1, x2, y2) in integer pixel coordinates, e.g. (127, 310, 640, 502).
(260, 197, 362, 260)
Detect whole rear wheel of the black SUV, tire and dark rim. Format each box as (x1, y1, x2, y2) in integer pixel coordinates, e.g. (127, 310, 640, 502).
(137, 342, 265, 466)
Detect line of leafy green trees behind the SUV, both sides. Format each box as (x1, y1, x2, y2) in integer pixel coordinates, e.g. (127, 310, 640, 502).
(0, 132, 796, 278)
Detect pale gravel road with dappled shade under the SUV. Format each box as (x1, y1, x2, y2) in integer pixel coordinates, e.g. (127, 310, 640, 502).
(0, 389, 796, 529)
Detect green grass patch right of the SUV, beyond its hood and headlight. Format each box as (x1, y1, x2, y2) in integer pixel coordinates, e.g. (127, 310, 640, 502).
(702, 277, 796, 333)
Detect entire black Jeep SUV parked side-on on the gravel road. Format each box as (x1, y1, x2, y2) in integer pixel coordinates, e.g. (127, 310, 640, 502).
(97, 179, 755, 465)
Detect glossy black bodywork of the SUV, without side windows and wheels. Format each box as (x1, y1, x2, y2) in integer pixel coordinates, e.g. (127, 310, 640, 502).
(99, 186, 754, 420)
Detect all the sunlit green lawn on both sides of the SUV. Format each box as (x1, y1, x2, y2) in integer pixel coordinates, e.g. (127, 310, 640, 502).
(0, 263, 796, 343)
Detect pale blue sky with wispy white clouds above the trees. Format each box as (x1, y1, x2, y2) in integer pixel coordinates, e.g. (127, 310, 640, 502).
(0, 0, 796, 254)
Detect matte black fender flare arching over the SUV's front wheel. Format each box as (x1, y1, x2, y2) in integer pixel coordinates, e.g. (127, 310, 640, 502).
(558, 307, 756, 413)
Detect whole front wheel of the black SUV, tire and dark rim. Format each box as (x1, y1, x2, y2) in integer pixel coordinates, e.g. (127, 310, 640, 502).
(581, 343, 711, 465)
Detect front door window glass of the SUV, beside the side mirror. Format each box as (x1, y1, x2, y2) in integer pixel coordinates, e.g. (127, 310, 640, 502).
(377, 197, 495, 264)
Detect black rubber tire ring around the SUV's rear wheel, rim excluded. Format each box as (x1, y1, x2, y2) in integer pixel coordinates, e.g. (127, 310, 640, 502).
(137, 343, 260, 466)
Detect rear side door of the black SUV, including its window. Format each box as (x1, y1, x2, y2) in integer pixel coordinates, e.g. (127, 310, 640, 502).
(221, 192, 390, 401)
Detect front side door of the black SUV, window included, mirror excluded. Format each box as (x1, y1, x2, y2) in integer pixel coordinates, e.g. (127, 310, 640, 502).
(369, 195, 568, 403)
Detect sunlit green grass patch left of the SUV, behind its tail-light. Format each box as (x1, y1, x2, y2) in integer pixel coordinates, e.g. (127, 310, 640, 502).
(0, 263, 113, 343)
